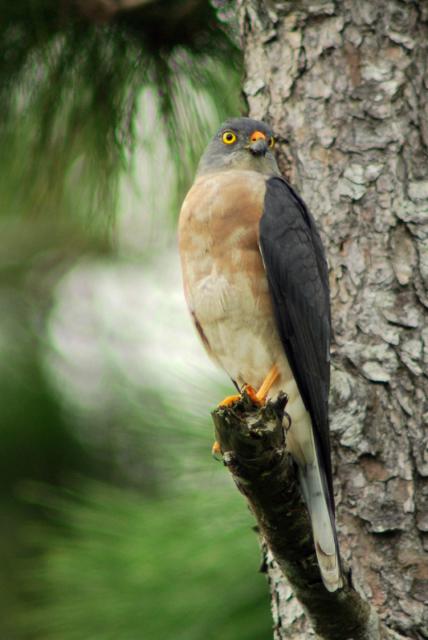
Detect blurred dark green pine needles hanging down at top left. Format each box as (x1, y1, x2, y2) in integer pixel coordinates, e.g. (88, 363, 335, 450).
(0, 0, 240, 236)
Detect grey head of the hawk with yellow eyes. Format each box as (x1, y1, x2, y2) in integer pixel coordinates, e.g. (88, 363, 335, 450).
(197, 118, 280, 175)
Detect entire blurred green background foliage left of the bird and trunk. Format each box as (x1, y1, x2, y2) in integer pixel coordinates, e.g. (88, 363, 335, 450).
(0, 0, 271, 640)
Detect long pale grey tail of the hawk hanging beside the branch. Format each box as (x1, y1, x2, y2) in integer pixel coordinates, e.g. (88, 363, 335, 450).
(298, 442, 343, 591)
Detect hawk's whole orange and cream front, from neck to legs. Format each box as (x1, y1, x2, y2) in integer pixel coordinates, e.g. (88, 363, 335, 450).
(179, 171, 278, 384)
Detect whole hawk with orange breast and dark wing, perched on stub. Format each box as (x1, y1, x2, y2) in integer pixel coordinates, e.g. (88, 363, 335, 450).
(178, 117, 343, 592)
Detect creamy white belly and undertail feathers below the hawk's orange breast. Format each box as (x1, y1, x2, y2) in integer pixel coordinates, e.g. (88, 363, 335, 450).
(189, 269, 313, 464)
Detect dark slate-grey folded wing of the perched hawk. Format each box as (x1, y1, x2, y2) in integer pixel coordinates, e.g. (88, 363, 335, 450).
(260, 177, 334, 498)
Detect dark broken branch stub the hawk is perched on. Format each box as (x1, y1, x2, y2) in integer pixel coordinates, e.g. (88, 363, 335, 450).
(212, 394, 391, 640)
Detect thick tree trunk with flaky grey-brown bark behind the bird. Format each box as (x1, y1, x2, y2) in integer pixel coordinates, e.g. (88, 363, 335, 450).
(239, 0, 428, 640)
